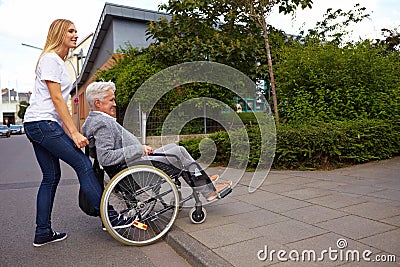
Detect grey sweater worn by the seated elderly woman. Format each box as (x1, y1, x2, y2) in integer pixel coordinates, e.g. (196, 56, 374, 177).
(82, 111, 142, 166)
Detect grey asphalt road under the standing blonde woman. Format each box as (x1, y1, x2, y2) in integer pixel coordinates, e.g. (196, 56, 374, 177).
(0, 135, 190, 267)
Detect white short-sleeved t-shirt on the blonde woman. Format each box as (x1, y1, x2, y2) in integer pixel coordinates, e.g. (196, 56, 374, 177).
(24, 53, 72, 125)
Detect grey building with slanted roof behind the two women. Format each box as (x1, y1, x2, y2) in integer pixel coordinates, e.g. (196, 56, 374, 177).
(71, 3, 169, 129)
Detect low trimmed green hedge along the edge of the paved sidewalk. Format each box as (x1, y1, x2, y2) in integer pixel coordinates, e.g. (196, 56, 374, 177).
(180, 119, 400, 169)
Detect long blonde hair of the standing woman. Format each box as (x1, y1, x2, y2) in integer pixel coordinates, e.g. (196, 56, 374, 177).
(36, 19, 74, 68)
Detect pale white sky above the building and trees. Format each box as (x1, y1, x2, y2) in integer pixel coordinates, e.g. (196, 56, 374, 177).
(0, 0, 400, 92)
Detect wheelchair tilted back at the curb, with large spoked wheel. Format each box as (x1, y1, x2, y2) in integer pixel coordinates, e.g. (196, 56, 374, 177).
(92, 153, 232, 246)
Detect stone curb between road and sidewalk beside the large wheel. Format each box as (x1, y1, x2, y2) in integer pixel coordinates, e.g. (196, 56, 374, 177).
(165, 226, 233, 267)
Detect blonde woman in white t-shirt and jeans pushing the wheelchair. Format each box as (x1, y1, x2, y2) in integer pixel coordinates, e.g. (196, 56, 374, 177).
(24, 19, 131, 247)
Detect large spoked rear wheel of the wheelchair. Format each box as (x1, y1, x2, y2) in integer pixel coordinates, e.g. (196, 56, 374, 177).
(100, 165, 180, 246)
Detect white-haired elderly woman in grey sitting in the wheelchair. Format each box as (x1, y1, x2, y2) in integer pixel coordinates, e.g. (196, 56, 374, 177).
(82, 82, 232, 201)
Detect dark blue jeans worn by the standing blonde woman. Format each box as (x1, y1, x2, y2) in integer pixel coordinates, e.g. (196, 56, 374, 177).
(24, 121, 103, 234)
